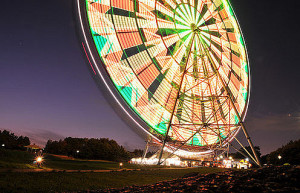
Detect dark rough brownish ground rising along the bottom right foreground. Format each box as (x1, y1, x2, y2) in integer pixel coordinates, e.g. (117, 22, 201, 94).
(89, 166, 300, 193)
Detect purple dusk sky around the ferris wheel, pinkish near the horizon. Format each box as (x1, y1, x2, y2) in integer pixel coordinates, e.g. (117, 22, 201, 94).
(0, 0, 300, 154)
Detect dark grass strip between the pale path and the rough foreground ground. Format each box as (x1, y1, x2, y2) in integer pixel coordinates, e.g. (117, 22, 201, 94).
(0, 168, 223, 192)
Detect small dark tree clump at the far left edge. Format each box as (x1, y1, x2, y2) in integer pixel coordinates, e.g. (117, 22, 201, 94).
(0, 130, 30, 150)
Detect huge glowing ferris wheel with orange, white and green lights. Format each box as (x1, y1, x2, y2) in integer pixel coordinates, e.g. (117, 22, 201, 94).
(77, 0, 259, 164)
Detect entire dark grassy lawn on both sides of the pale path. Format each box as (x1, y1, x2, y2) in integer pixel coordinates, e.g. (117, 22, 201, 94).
(0, 149, 224, 192)
